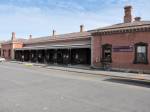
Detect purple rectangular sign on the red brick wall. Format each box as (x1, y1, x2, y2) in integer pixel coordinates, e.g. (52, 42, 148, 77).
(113, 46, 133, 52)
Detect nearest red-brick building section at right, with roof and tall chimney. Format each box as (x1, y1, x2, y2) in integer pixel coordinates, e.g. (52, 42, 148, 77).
(91, 6, 150, 72)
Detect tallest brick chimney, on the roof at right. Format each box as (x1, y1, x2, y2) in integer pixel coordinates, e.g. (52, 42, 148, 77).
(124, 6, 132, 23)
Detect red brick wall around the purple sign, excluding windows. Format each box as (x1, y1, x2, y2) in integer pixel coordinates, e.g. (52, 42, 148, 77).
(92, 32, 150, 69)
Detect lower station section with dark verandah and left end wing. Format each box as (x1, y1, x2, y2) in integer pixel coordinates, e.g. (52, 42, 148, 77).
(1, 25, 91, 65)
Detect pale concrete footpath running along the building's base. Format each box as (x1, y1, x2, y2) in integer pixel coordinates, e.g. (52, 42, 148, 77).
(11, 61, 150, 82)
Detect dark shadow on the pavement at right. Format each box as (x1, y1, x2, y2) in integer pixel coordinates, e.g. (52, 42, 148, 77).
(104, 78, 150, 88)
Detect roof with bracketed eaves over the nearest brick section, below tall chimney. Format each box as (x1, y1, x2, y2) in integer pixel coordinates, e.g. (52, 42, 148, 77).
(90, 21, 150, 33)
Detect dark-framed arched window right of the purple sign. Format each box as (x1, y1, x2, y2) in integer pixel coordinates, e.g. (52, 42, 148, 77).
(134, 42, 148, 64)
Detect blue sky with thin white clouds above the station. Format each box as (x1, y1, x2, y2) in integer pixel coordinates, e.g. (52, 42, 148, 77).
(0, 0, 150, 41)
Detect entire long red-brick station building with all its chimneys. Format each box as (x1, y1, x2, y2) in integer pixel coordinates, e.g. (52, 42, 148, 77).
(1, 6, 150, 73)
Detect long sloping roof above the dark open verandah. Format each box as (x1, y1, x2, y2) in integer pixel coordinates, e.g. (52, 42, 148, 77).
(24, 32, 90, 44)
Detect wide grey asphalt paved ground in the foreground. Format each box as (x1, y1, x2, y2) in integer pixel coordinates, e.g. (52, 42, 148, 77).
(0, 62, 150, 112)
